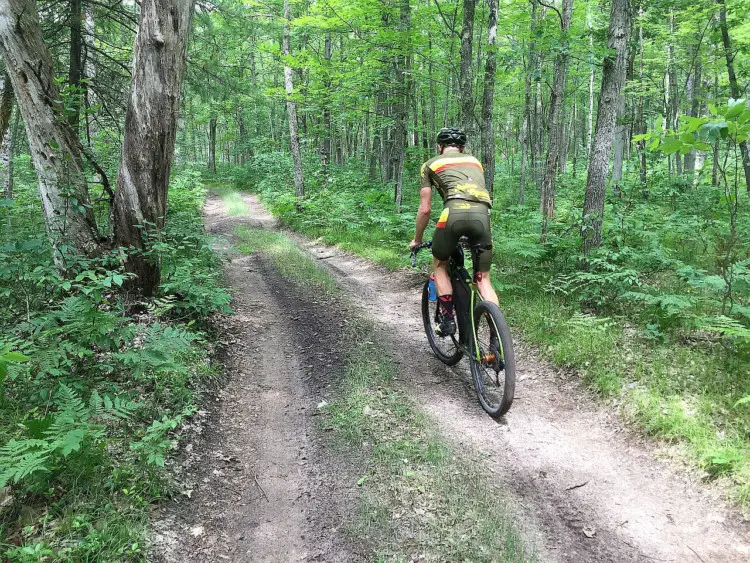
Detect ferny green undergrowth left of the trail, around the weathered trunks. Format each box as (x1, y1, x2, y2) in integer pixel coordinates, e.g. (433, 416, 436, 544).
(0, 170, 229, 562)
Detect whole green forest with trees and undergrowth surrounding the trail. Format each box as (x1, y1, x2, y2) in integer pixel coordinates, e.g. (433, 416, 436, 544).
(0, 0, 750, 561)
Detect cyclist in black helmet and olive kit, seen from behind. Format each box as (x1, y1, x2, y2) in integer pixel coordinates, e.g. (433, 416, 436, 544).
(409, 127, 498, 336)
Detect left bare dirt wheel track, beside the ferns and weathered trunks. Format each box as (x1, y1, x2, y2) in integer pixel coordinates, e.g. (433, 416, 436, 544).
(153, 197, 362, 563)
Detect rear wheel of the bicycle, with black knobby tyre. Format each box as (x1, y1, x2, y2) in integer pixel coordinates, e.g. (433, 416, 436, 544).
(469, 301, 516, 418)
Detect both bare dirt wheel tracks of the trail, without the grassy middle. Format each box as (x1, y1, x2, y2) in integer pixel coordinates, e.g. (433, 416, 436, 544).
(151, 194, 750, 563)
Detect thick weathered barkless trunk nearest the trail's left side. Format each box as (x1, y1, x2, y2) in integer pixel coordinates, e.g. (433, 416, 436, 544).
(114, 0, 195, 295)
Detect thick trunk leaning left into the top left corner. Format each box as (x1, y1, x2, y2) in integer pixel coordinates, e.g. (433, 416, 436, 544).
(0, 0, 100, 264)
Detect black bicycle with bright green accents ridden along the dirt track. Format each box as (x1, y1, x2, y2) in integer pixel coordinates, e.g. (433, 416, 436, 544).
(411, 237, 516, 418)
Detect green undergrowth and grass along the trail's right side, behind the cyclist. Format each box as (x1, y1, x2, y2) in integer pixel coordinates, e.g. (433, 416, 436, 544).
(228, 154, 750, 505)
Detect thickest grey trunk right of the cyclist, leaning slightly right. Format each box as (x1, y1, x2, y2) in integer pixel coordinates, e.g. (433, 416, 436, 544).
(582, 0, 630, 255)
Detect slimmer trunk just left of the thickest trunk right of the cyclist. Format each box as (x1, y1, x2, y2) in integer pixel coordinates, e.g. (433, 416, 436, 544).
(540, 0, 573, 240)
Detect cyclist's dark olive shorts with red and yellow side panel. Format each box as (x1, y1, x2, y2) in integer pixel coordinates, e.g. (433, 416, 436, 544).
(432, 199, 492, 272)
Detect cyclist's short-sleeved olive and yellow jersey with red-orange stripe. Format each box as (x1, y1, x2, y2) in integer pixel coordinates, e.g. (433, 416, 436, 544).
(420, 151, 492, 207)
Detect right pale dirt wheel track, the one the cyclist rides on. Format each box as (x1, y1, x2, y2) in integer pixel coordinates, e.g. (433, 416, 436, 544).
(238, 195, 750, 563)
